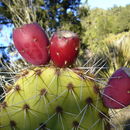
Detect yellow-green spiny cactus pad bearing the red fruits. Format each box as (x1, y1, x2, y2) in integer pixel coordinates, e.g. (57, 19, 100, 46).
(0, 67, 110, 130)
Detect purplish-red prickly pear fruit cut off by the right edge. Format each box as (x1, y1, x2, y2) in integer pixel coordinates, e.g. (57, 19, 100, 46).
(103, 68, 130, 109)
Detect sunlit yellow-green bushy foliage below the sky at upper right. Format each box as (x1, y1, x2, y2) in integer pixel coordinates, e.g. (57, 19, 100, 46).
(81, 5, 130, 53)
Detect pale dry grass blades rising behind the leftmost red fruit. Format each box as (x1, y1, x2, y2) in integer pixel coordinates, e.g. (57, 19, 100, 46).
(2, 0, 37, 27)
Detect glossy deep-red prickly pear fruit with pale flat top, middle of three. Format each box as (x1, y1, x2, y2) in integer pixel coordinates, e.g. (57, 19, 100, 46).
(50, 31, 80, 67)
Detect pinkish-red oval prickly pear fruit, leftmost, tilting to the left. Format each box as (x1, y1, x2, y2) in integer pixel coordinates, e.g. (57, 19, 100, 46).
(13, 23, 50, 65)
